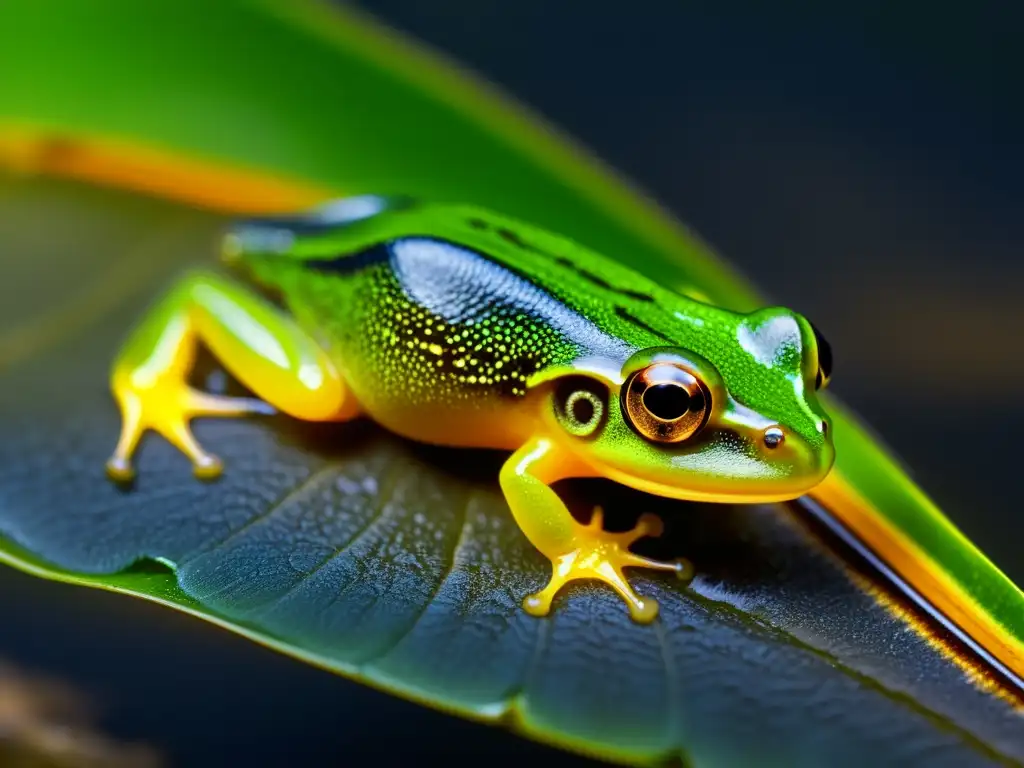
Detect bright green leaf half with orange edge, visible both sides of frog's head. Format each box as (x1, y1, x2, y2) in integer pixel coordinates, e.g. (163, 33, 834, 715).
(0, 0, 1024, 671)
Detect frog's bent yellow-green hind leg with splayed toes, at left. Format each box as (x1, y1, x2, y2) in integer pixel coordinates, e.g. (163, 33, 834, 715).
(106, 273, 357, 480)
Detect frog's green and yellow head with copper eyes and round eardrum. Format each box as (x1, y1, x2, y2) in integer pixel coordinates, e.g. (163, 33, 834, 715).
(547, 307, 835, 502)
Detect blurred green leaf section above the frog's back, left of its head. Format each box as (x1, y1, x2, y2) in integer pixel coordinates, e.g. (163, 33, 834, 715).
(0, 0, 754, 303)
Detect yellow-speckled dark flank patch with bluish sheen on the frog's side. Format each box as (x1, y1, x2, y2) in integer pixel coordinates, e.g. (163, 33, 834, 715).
(296, 238, 610, 404)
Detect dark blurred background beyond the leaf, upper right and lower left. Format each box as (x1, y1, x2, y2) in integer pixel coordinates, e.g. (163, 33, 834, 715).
(0, 0, 1024, 766)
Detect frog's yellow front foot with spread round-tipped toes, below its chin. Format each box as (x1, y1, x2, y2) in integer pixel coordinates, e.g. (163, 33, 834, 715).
(523, 507, 692, 624)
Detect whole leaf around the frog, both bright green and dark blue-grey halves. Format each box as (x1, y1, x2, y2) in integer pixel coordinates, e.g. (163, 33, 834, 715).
(0, 0, 1024, 765)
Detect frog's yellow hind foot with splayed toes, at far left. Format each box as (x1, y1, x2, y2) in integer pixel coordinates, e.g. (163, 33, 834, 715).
(106, 381, 271, 482)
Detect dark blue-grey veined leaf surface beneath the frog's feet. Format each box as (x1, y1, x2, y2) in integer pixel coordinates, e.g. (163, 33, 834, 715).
(0, 174, 1024, 766)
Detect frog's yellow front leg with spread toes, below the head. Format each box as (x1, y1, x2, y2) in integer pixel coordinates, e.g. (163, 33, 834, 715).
(501, 437, 691, 623)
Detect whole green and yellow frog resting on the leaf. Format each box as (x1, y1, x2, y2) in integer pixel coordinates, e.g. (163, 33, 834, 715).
(106, 195, 835, 624)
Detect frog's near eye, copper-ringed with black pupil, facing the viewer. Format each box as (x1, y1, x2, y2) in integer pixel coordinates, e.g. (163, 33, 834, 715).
(623, 362, 711, 442)
